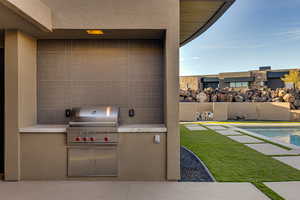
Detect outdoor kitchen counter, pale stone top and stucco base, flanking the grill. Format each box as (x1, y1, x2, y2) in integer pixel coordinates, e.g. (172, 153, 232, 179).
(19, 124, 167, 181)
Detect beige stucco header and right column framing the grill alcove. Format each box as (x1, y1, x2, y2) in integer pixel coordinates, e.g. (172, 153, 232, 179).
(42, 0, 180, 180)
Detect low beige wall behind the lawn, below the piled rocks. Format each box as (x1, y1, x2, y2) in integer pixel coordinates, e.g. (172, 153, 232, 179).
(179, 102, 294, 121)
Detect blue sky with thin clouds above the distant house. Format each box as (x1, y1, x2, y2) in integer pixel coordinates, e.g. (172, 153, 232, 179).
(180, 0, 300, 75)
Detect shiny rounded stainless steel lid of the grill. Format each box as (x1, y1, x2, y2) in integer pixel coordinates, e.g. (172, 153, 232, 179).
(69, 106, 119, 126)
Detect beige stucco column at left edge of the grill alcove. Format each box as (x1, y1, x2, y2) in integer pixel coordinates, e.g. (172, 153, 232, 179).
(4, 31, 20, 181)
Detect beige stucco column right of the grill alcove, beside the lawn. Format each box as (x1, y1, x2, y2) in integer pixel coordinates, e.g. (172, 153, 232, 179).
(165, 2, 180, 180)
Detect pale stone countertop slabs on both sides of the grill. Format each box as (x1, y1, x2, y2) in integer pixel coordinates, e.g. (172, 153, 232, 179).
(19, 124, 167, 133)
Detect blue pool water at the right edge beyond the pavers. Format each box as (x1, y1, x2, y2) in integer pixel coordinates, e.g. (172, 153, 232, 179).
(239, 127, 300, 146)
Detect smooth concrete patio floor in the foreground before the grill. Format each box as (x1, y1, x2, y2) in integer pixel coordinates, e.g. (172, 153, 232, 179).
(0, 181, 268, 200)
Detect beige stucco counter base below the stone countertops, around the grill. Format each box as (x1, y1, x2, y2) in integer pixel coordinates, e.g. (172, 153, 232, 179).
(21, 133, 166, 181)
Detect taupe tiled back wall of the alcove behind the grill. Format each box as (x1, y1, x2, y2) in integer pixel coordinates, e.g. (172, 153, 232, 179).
(38, 40, 164, 124)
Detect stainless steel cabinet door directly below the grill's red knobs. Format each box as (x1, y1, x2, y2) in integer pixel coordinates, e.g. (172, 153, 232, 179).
(68, 146, 118, 177)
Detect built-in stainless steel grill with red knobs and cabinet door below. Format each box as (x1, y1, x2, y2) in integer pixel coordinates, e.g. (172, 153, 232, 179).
(67, 106, 119, 177)
